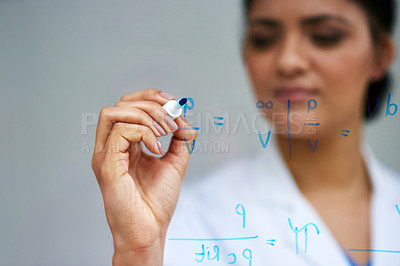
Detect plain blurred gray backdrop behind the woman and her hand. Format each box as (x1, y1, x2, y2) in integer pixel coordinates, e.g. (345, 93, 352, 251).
(0, 0, 400, 265)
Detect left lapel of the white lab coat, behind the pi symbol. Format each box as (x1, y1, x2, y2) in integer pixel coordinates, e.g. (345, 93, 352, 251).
(258, 137, 354, 266)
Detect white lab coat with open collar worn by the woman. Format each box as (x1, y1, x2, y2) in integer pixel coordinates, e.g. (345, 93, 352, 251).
(164, 138, 400, 266)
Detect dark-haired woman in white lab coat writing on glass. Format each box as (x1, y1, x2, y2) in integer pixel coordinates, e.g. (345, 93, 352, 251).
(92, 0, 400, 265)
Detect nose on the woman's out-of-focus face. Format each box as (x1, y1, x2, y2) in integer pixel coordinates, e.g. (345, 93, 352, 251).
(276, 34, 309, 77)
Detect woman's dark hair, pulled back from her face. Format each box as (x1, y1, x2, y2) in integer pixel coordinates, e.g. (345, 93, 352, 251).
(243, 0, 397, 121)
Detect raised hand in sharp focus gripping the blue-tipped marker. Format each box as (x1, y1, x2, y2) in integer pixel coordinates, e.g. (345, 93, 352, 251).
(92, 89, 197, 262)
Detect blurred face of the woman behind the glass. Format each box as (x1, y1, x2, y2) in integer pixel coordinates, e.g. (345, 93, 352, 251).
(243, 0, 376, 138)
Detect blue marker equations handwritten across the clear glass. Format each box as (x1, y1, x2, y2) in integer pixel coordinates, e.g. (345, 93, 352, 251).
(168, 93, 400, 266)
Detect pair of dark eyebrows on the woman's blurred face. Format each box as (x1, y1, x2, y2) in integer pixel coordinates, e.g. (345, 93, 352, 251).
(249, 15, 350, 28)
